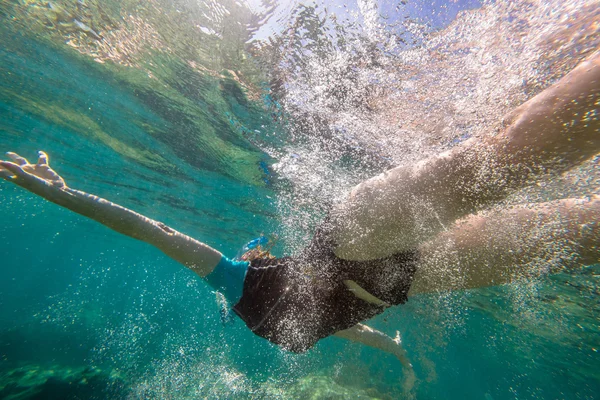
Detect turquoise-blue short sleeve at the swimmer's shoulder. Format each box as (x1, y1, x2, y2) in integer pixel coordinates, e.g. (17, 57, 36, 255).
(205, 256, 250, 304)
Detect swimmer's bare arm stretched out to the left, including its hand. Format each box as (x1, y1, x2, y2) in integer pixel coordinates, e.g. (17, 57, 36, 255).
(0, 151, 223, 276)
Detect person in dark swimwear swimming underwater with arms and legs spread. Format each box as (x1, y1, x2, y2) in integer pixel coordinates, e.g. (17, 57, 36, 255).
(0, 53, 600, 363)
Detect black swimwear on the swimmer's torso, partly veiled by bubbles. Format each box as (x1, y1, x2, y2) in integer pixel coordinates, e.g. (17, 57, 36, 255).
(233, 227, 417, 353)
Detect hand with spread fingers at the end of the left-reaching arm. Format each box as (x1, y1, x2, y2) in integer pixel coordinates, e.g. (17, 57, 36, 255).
(0, 151, 67, 190)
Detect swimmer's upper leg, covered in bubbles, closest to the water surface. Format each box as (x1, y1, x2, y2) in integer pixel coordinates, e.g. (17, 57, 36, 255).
(331, 53, 600, 260)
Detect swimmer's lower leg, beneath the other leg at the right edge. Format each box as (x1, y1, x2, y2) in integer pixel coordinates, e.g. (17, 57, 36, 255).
(409, 196, 600, 296)
